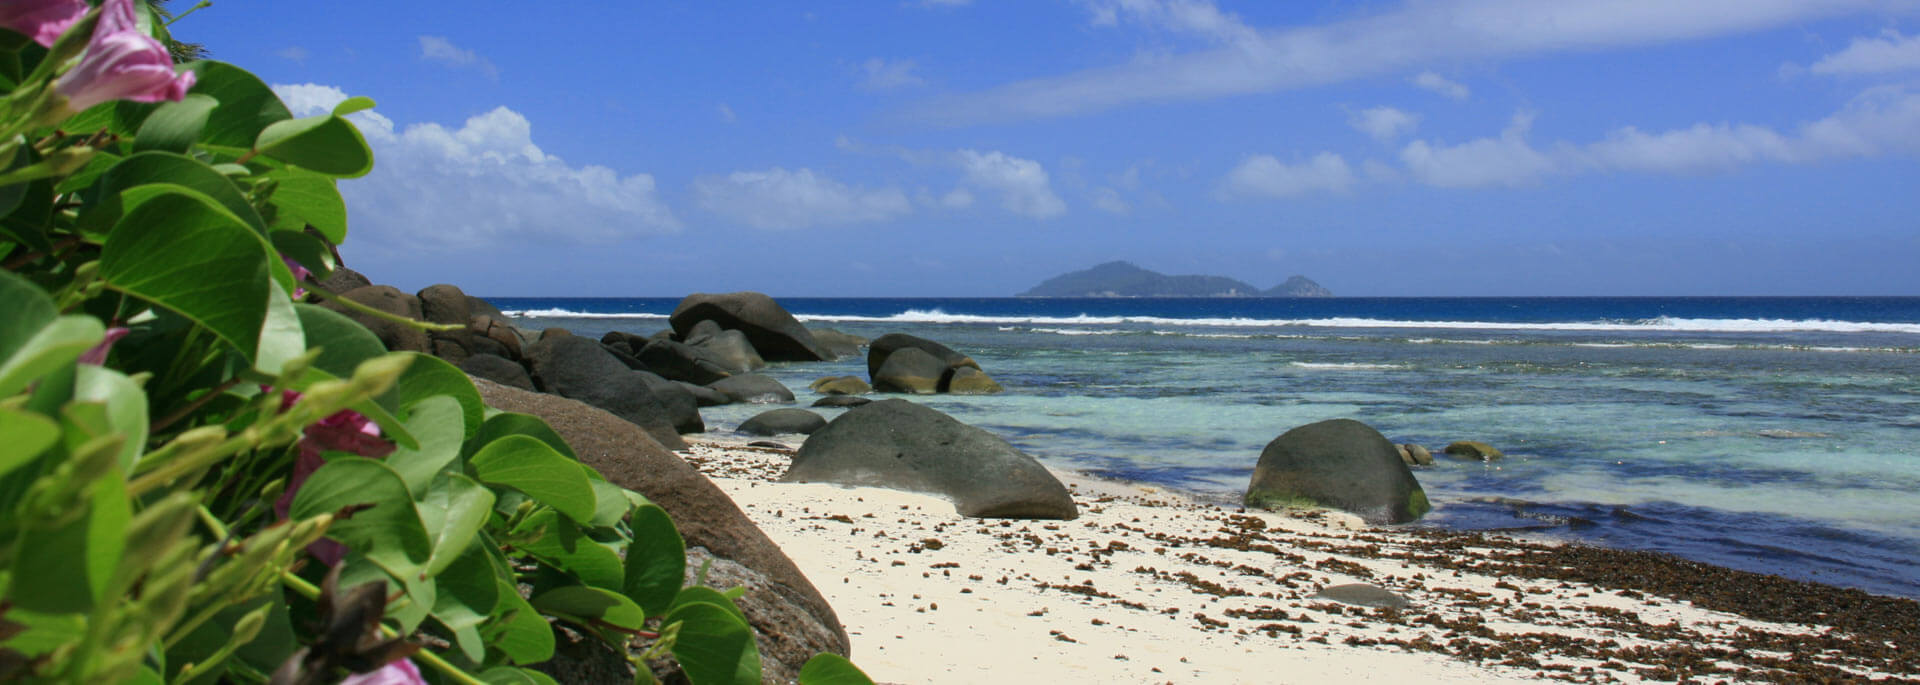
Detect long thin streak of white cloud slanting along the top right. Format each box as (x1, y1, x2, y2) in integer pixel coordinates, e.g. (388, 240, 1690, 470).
(910, 0, 1882, 125)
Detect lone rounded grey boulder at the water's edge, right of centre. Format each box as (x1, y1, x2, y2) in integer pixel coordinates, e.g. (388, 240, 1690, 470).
(1246, 418, 1432, 524)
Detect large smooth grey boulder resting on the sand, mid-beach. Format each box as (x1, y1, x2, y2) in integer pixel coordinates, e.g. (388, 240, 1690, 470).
(781, 399, 1079, 520)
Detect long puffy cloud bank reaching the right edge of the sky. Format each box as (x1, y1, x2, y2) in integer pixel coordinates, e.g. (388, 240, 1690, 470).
(1400, 86, 1920, 188)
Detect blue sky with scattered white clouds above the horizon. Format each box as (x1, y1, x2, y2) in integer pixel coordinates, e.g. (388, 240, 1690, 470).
(173, 0, 1920, 297)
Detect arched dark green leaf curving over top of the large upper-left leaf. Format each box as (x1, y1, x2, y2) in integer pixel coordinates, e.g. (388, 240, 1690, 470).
(79, 150, 267, 236)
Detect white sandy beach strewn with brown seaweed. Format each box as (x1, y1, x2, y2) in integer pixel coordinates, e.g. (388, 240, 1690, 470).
(682, 436, 1920, 683)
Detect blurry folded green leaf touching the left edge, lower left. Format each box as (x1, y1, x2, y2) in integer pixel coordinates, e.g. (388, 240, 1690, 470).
(8, 470, 132, 612)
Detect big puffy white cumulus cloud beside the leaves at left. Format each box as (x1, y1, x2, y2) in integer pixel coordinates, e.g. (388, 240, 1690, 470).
(273, 83, 680, 248)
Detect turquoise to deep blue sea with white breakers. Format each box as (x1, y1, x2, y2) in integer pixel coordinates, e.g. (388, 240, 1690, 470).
(490, 297, 1920, 597)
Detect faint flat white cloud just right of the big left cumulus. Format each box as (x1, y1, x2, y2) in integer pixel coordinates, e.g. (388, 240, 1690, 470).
(693, 167, 914, 228)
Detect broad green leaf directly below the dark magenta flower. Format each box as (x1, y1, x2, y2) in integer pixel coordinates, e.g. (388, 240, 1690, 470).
(290, 457, 432, 579)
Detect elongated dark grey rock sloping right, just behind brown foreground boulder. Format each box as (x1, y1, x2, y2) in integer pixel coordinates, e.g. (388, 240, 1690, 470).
(526, 334, 687, 449)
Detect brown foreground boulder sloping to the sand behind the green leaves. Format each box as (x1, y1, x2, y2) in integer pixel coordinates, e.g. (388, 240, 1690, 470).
(474, 380, 849, 683)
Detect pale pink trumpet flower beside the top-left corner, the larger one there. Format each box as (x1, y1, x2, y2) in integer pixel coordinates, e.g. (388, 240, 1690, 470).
(54, 0, 194, 111)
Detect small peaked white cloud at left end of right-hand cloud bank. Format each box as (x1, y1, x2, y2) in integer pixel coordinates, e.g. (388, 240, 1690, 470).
(1400, 113, 1561, 188)
